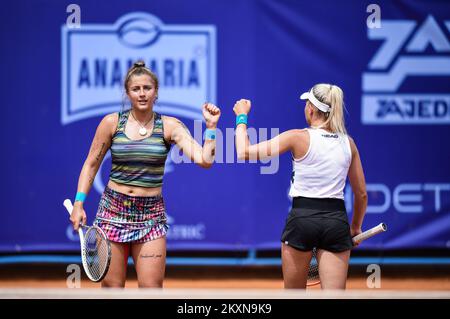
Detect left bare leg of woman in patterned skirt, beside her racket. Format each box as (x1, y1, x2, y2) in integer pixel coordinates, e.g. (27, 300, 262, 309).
(102, 242, 129, 288)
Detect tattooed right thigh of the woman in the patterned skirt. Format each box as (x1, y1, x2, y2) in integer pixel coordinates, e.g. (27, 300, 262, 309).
(131, 236, 166, 288)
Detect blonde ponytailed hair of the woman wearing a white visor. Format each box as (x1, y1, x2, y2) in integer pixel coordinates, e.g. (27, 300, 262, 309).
(311, 83, 347, 134)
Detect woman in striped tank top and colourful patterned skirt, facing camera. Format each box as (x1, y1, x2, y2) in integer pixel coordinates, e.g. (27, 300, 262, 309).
(71, 62, 220, 288)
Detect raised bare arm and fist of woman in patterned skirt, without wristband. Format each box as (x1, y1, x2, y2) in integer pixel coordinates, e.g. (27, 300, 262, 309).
(164, 104, 220, 168)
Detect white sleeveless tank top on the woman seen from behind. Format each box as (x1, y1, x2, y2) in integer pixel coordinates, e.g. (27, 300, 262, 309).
(289, 128, 352, 199)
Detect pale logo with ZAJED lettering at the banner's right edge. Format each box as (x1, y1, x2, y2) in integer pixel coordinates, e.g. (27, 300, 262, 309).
(361, 16, 450, 124)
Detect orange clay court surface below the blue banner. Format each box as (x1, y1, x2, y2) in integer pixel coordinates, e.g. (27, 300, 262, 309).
(0, 264, 450, 298)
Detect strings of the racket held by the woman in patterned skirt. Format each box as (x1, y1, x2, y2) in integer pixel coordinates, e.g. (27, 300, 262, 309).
(84, 227, 110, 280)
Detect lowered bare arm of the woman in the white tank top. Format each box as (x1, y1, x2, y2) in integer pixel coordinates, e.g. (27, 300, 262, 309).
(348, 138, 367, 236)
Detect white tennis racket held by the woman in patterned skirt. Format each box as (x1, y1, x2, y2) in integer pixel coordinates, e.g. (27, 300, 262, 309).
(63, 199, 111, 282)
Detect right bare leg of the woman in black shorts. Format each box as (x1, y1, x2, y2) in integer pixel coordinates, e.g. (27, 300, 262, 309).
(317, 249, 350, 289)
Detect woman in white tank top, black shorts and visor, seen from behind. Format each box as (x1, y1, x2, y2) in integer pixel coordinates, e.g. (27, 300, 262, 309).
(233, 84, 367, 289)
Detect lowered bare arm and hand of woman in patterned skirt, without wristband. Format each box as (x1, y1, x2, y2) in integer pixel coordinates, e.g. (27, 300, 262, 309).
(70, 114, 118, 229)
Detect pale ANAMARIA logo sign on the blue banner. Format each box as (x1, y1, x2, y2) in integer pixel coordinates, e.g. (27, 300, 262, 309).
(61, 12, 216, 125)
